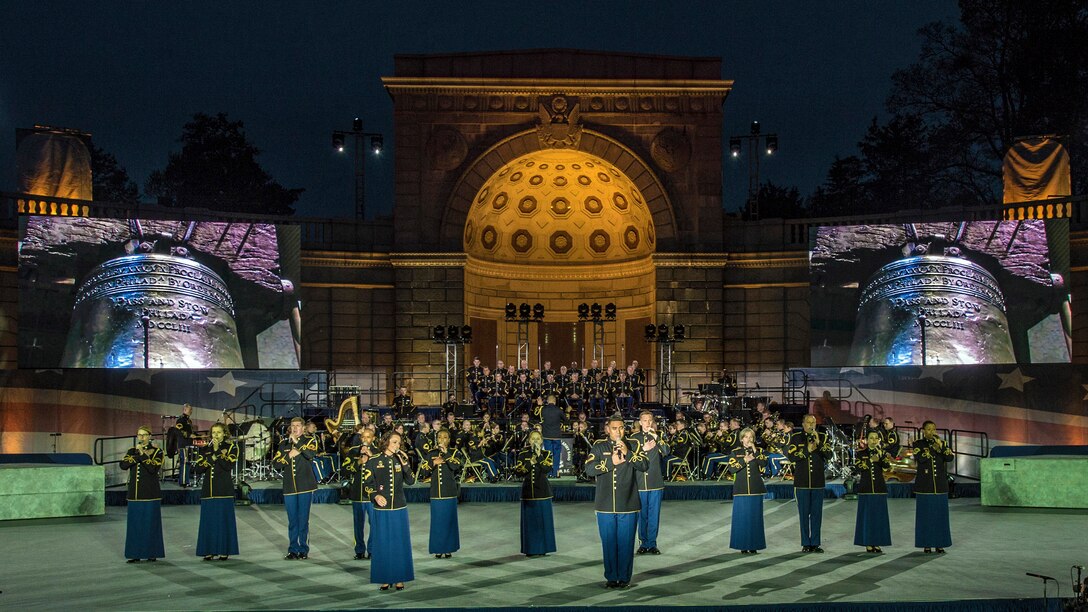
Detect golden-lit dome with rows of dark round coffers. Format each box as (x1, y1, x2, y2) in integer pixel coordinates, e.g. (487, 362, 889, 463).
(463, 149, 656, 264)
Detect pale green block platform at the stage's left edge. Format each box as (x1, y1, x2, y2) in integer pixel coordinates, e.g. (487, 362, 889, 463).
(0, 463, 103, 521)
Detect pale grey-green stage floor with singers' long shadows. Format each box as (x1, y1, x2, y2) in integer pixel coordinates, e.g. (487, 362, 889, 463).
(0, 499, 1074, 610)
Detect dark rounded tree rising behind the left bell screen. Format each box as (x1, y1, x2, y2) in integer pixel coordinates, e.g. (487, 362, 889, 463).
(145, 113, 304, 215)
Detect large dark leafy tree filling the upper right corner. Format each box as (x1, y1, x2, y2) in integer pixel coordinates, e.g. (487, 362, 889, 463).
(888, 0, 1088, 198)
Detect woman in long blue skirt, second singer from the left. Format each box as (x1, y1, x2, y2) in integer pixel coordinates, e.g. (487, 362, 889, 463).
(196, 423, 238, 561)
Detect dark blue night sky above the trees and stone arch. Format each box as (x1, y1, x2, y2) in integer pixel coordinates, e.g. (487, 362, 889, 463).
(0, 0, 957, 217)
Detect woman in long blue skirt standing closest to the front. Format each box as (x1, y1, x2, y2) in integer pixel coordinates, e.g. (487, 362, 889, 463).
(363, 432, 416, 590)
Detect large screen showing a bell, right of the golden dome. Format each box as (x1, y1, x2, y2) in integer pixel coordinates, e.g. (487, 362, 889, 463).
(809, 220, 1072, 367)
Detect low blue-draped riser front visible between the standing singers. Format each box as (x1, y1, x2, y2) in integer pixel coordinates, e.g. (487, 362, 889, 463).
(106, 476, 979, 505)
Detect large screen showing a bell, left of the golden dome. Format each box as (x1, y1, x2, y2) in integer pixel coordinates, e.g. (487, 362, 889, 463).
(18, 217, 300, 369)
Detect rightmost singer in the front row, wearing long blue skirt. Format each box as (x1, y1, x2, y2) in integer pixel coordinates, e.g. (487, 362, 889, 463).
(914, 420, 955, 554)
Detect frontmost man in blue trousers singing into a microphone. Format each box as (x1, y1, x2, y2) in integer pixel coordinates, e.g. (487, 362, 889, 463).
(585, 415, 654, 588)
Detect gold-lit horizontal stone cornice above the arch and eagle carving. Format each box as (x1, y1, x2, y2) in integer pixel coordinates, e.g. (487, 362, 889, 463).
(382, 76, 733, 97)
